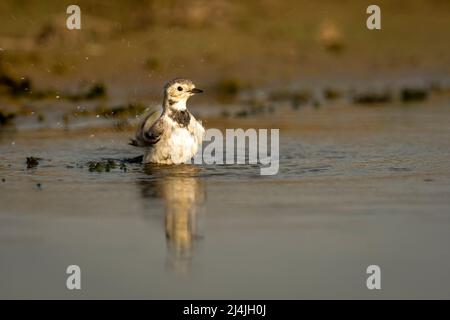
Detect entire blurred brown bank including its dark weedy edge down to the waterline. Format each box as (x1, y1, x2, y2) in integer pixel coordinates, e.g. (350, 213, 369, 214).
(0, 0, 450, 129)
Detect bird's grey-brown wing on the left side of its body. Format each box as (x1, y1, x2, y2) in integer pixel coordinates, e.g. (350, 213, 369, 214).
(130, 111, 164, 147)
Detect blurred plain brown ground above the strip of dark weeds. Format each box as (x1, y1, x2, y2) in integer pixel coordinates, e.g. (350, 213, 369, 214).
(0, 0, 450, 93)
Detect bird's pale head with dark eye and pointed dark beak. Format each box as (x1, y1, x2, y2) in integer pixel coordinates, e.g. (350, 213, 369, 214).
(164, 78, 203, 110)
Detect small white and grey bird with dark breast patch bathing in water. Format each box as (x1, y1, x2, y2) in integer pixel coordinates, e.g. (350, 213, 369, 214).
(130, 78, 205, 165)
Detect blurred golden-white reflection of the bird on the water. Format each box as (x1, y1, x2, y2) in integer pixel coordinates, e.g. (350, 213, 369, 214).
(140, 165, 206, 273)
